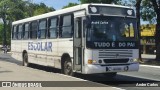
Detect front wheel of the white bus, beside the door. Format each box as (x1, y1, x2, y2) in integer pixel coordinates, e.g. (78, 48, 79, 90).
(62, 57, 74, 76)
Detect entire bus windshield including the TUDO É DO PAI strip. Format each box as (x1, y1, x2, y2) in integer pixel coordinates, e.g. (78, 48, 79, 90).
(86, 16, 138, 49)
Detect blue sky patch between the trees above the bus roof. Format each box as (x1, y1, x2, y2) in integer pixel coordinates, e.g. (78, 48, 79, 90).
(31, 0, 80, 10)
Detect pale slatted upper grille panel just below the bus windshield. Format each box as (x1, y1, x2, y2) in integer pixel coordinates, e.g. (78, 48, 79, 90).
(99, 50, 133, 59)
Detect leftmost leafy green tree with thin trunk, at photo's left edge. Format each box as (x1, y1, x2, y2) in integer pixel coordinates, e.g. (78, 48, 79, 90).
(0, 0, 23, 45)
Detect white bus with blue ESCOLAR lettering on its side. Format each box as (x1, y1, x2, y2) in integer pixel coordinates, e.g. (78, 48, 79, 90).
(11, 4, 139, 76)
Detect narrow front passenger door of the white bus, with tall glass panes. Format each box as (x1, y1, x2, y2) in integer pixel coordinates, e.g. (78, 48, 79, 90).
(73, 17, 85, 71)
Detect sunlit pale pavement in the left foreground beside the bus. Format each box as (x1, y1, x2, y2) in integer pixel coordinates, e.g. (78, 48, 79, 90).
(0, 53, 118, 90)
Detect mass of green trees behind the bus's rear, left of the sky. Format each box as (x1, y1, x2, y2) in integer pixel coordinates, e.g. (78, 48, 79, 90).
(0, 0, 54, 45)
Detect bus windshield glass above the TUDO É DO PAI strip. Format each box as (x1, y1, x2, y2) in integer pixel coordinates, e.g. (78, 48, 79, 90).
(87, 17, 137, 41)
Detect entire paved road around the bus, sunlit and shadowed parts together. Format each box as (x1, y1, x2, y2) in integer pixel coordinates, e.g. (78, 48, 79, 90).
(0, 54, 160, 90)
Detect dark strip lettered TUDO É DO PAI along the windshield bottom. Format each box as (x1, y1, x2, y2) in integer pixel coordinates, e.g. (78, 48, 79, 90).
(87, 41, 138, 49)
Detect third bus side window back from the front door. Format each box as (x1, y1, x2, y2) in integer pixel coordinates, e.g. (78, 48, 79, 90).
(38, 20, 47, 38)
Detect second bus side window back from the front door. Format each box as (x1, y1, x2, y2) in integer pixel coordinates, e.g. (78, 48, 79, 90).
(48, 18, 58, 38)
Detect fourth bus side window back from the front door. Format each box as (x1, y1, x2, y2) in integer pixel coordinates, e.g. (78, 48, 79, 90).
(30, 21, 38, 39)
